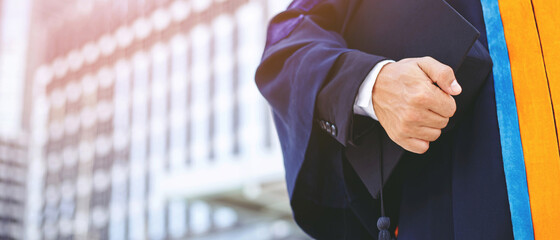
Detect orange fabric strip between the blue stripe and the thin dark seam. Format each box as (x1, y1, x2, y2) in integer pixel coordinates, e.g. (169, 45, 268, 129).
(499, 0, 560, 239)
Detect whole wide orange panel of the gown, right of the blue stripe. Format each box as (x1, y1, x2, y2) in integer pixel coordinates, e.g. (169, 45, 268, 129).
(499, 0, 560, 239)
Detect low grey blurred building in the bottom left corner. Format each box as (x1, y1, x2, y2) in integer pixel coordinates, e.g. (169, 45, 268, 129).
(0, 139, 27, 239)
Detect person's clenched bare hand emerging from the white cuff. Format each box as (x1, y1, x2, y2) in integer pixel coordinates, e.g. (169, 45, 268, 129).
(372, 57, 461, 154)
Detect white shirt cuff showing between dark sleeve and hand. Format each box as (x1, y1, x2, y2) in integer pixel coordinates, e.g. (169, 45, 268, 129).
(354, 60, 395, 121)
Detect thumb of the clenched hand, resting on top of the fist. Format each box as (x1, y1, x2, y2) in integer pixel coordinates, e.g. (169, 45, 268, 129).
(418, 57, 462, 96)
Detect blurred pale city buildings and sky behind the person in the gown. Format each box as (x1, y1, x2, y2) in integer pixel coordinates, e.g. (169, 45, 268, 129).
(0, 0, 307, 240)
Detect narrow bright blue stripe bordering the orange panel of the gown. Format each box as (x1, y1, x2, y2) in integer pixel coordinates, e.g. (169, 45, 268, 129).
(481, 0, 535, 240)
